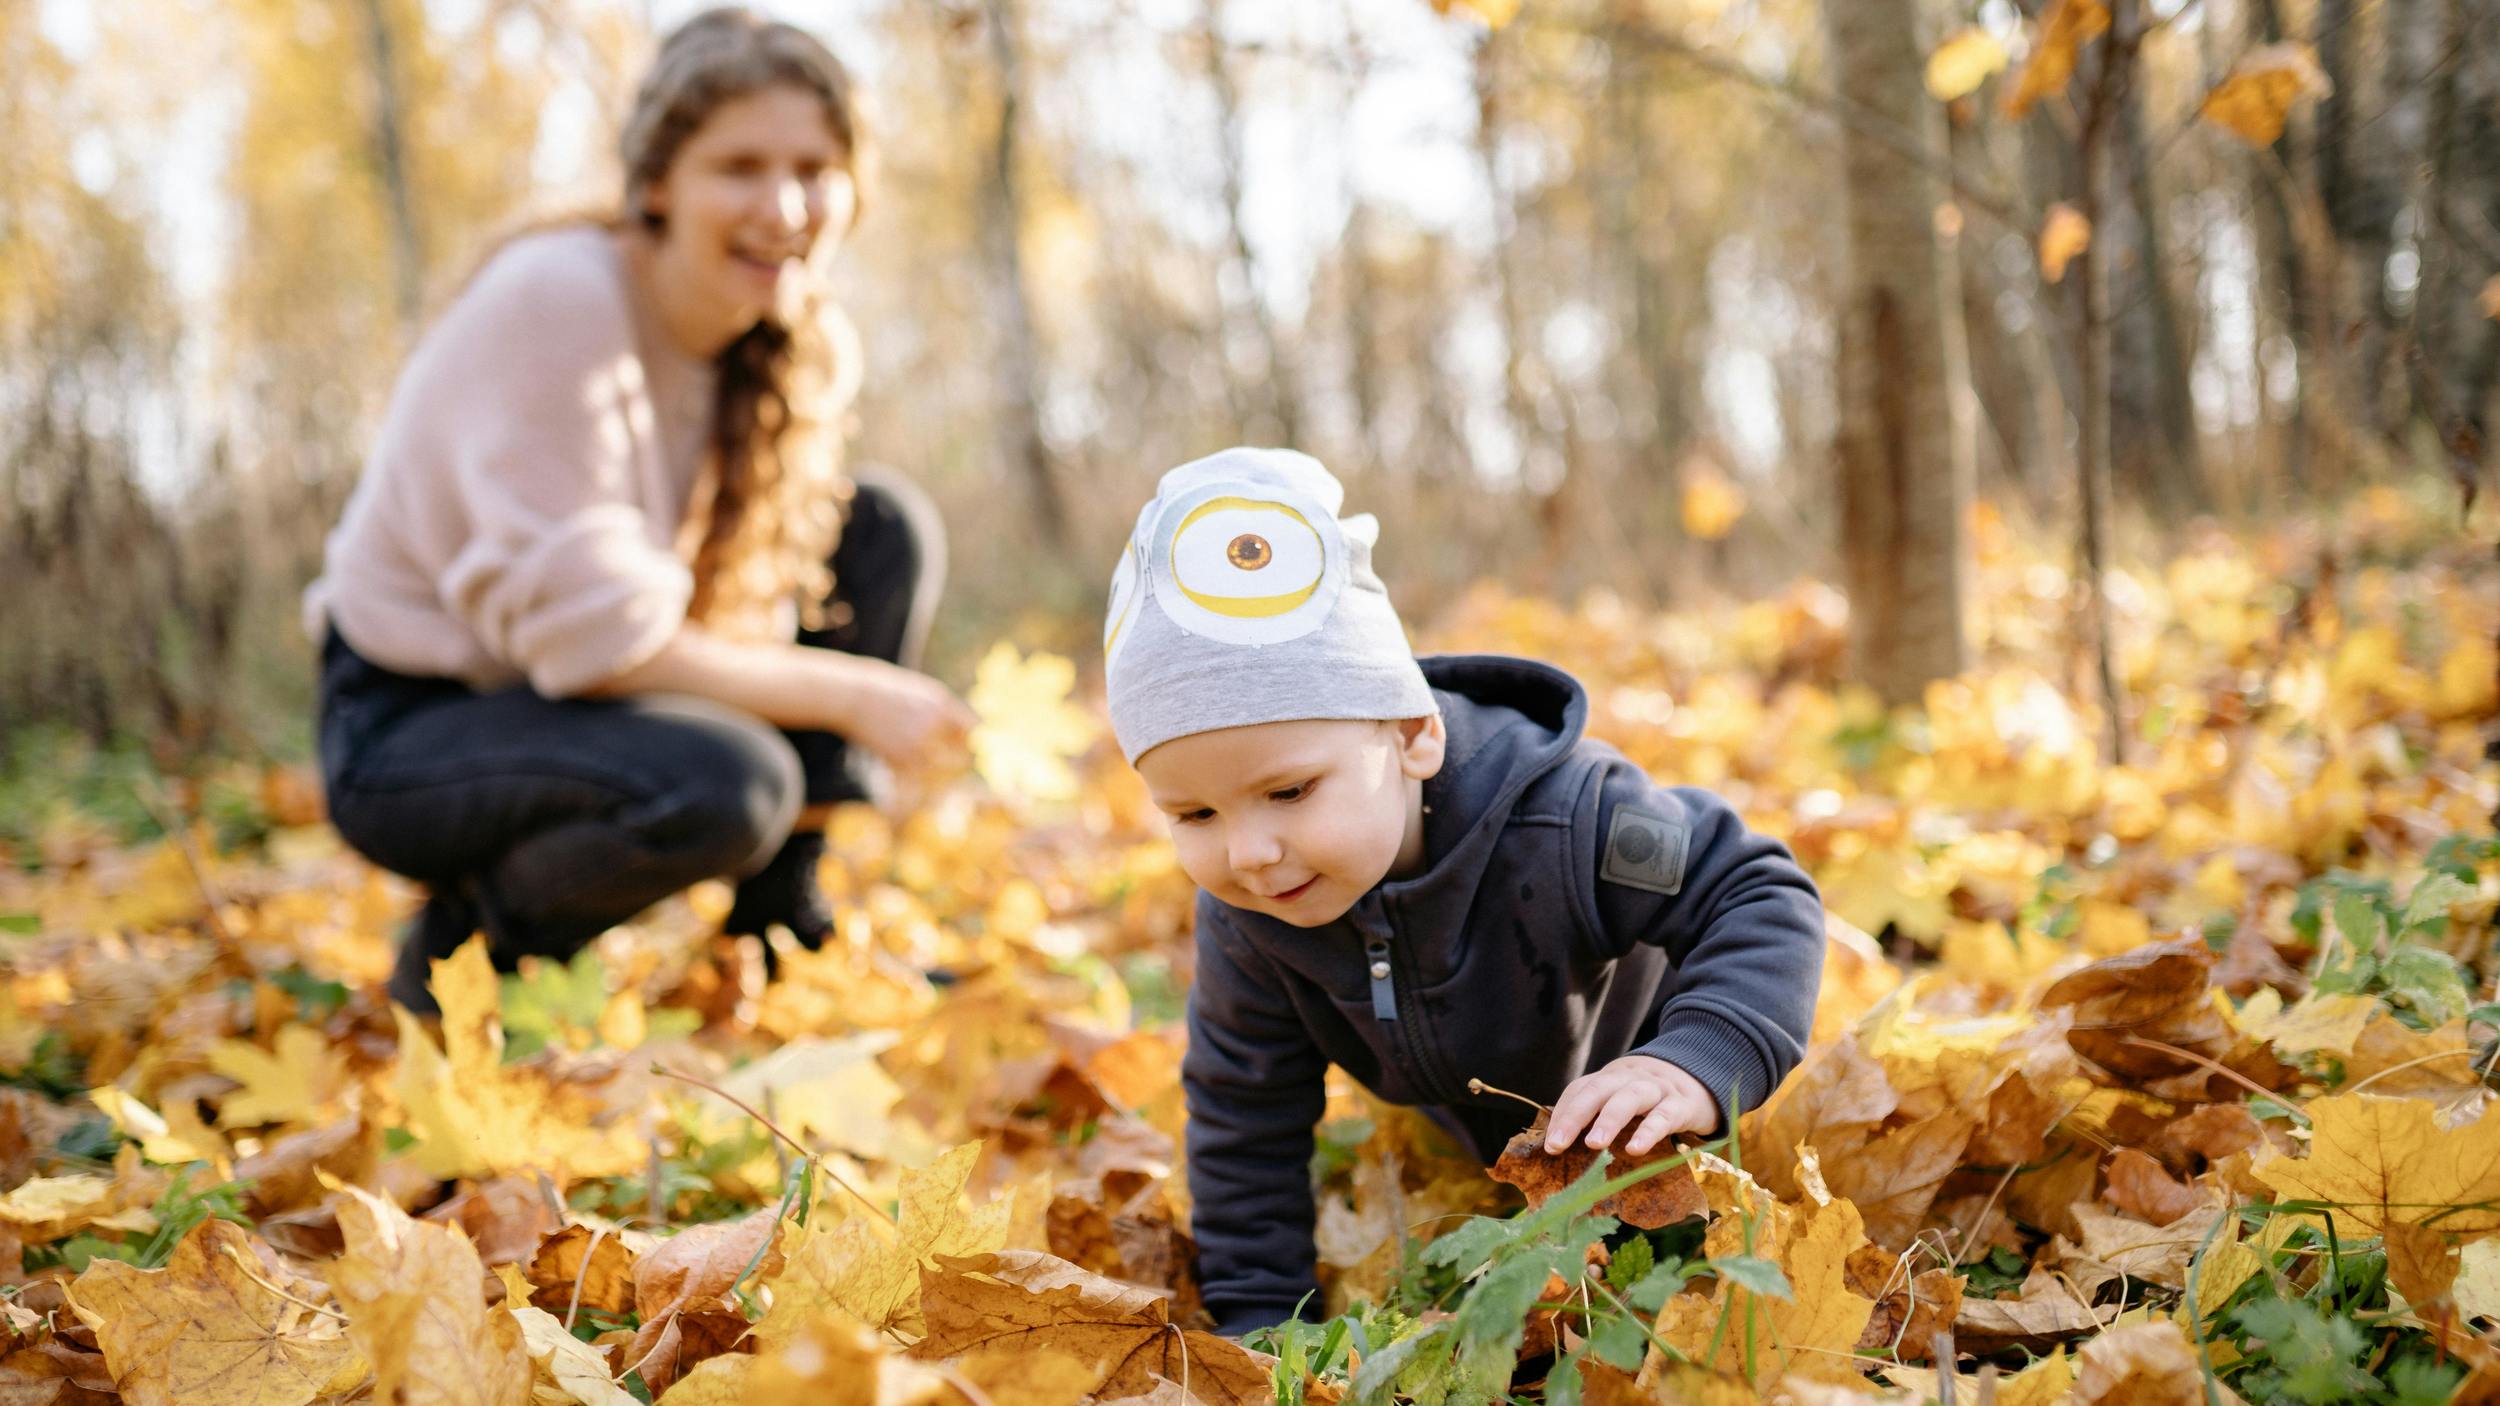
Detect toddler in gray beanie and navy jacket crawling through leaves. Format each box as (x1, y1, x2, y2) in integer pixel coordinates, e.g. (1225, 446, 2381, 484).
(1103, 448, 1823, 1336)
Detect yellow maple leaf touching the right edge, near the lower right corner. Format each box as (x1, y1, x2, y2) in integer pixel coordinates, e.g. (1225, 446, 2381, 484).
(2255, 1093, 2500, 1236)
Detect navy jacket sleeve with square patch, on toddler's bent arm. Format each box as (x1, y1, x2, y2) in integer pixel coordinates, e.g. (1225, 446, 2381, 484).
(1593, 763, 1823, 1111)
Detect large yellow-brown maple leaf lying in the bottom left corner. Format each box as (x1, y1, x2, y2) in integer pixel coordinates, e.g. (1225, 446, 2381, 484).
(70, 1218, 367, 1406)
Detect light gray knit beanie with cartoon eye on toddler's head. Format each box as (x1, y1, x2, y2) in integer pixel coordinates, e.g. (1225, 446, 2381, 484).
(1103, 448, 1435, 763)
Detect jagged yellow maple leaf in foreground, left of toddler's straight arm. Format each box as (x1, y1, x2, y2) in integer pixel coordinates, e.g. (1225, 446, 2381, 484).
(755, 1143, 1015, 1346)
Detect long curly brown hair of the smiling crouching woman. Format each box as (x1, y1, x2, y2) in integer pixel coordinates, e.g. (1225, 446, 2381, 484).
(618, 8, 870, 628)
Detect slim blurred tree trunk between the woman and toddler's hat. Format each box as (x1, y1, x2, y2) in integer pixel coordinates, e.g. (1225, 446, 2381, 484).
(980, 0, 1068, 548)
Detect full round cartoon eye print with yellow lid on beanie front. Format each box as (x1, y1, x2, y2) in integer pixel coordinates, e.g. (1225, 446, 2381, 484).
(1153, 483, 1345, 645)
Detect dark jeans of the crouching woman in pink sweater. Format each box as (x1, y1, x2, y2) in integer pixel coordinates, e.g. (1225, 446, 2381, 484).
(320, 480, 945, 966)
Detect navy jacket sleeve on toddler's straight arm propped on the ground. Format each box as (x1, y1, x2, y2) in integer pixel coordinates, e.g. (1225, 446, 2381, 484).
(1180, 898, 1328, 1336)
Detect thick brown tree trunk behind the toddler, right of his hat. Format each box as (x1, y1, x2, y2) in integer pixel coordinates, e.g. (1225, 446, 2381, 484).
(1823, 0, 1973, 703)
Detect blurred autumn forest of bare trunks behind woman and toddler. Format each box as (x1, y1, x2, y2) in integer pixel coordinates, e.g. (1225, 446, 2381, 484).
(0, 0, 2500, 756)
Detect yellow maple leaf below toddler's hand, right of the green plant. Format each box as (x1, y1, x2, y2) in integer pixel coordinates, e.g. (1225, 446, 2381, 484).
(1658, 1166, 1875, 1383)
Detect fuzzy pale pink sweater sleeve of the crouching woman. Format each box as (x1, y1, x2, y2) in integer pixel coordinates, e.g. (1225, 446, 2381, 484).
(418, 243, 693, 698)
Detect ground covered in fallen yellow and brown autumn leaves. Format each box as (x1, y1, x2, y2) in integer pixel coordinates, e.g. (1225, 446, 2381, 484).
(0, 493, 2500, 1406)
